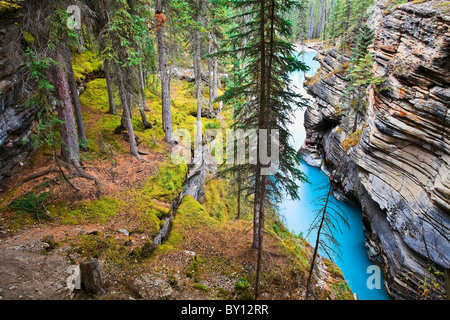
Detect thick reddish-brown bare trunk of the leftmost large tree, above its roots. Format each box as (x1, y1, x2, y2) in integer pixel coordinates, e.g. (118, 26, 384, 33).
(54, 47, 80, 164)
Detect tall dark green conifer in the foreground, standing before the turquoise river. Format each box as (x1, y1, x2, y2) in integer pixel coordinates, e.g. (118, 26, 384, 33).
(222, 0, 312, 296)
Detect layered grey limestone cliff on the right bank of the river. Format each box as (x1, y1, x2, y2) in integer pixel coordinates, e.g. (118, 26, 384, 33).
(302, 1, 450, 299)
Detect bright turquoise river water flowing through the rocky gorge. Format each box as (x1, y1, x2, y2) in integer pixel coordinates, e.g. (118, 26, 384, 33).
(280, 51, 389, 300)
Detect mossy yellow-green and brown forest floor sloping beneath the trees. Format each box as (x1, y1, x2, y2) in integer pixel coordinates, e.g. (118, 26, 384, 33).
(0, 58, 352, 300)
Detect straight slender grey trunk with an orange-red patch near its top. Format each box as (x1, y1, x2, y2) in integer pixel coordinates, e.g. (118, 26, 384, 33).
(155, 0, 174, 144)
